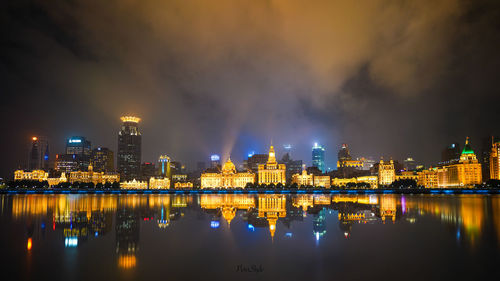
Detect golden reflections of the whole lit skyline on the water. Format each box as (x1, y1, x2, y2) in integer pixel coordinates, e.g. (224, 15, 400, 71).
(6, 194, 500, 252)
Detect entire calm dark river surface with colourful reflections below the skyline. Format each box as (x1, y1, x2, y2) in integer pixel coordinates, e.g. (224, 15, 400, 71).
(0, 195, 500, 281)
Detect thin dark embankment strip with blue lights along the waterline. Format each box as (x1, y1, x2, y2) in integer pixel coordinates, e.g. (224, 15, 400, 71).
(0, 188, 500, 195)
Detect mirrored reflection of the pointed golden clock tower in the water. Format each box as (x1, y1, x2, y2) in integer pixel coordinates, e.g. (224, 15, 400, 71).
(259, 195, 286, 238)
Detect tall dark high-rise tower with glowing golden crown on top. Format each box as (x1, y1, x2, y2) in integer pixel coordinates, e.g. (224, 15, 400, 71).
(117, 116, 141, 181)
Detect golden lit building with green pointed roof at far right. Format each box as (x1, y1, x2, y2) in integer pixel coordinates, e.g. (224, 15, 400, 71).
(437, 137, 482, 188)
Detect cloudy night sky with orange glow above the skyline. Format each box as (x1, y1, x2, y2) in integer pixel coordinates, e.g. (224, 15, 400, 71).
(0, 0, 500, 177)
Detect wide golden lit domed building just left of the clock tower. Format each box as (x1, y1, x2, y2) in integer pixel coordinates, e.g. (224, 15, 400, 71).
(201, 158, 255, 188)
